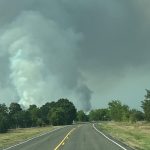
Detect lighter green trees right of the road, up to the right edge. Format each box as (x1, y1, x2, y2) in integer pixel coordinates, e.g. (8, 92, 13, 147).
(77, 90, 150, 123)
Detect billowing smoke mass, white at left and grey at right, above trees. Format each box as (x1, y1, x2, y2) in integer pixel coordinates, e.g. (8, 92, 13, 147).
(1, 11, 91, 110)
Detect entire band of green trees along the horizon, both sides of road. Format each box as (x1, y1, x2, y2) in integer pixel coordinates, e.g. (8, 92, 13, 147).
(0, 90, 150, 133)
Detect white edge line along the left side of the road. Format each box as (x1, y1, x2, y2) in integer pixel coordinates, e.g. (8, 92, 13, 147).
(3, 126, 67, 150)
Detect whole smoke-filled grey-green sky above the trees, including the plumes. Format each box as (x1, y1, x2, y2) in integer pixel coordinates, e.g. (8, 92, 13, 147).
(0, 0, 150, 110)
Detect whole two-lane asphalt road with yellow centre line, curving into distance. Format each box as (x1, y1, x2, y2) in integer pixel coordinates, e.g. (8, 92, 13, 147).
(5, 124, 132, 150)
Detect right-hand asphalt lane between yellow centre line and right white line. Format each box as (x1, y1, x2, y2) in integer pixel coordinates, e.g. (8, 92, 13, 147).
(62, 124, 134, 150)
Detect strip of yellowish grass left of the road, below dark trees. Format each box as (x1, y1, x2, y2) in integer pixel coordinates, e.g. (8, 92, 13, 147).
(0, 126, 54, 149)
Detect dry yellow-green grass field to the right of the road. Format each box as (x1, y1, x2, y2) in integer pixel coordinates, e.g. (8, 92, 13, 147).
(99, 122, 150, 150)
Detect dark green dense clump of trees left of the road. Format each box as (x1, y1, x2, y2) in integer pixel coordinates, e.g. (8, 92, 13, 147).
(0, 99, 76, 133)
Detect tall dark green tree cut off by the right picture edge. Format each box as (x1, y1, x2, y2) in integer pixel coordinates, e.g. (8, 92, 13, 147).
(141, 90, 150, 121)
